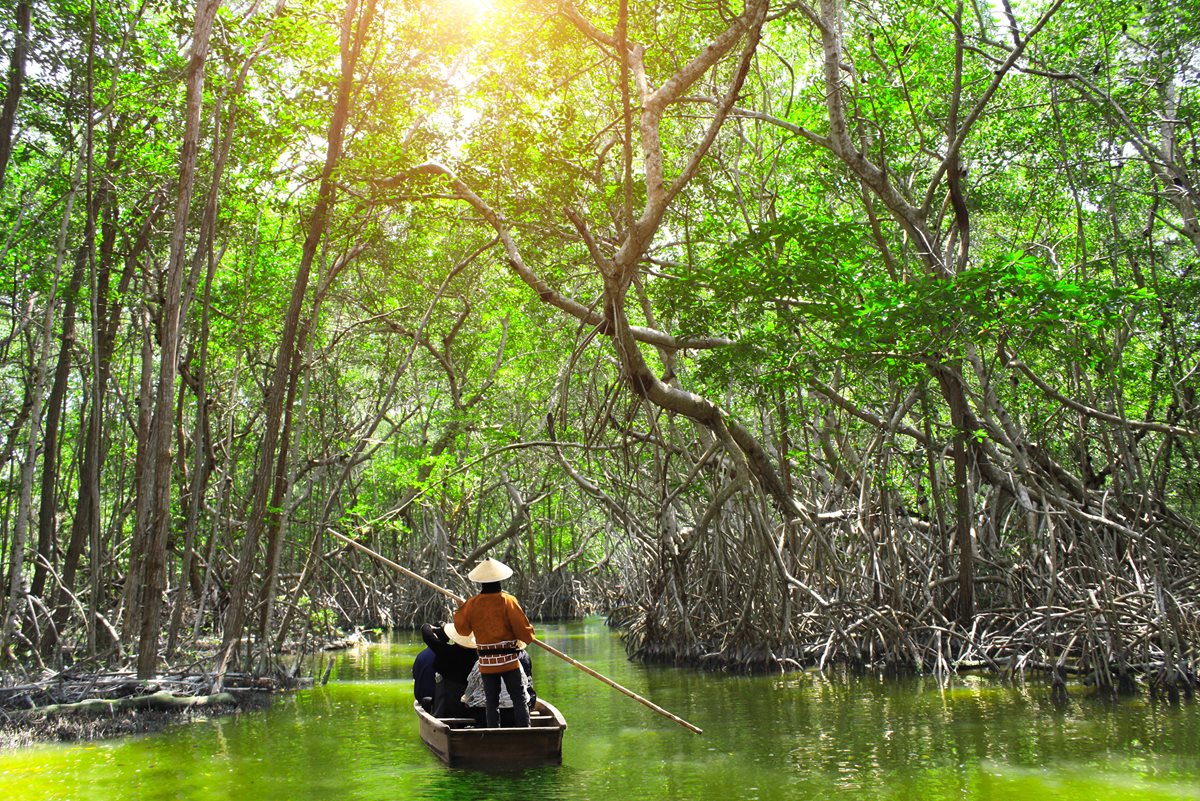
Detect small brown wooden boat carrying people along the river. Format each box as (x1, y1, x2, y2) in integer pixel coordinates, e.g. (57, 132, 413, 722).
(413, 698, 566, 770)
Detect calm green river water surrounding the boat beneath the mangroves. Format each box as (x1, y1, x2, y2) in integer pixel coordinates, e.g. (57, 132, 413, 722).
(0, 621, 1200, 801)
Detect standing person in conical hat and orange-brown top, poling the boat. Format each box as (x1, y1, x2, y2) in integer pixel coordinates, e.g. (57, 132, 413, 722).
(454, 558, 534, 729)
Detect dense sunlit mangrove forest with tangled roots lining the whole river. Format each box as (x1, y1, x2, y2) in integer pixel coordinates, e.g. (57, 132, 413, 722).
(0, 0, 1200, 697)
